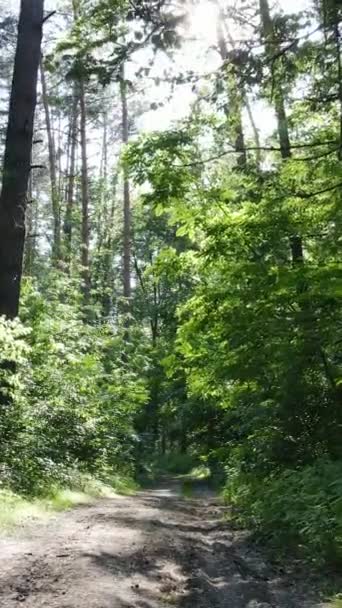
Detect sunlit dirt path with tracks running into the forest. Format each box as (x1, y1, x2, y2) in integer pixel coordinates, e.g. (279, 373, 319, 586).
(0, 487, 319, 608)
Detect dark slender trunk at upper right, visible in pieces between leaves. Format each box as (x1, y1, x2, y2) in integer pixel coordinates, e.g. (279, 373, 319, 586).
(259, 0, 304, 265)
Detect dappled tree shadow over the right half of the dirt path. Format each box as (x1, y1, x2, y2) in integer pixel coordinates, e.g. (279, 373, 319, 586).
(81, 495, 318, 608)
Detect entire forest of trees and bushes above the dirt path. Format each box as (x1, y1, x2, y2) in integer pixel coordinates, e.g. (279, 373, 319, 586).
(0, 0, 342, 576)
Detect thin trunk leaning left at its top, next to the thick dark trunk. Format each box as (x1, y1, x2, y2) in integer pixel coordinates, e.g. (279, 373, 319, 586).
(40, 57, 61, 263)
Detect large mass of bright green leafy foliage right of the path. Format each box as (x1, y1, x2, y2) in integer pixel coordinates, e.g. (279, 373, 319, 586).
(126, 71, 342, 564)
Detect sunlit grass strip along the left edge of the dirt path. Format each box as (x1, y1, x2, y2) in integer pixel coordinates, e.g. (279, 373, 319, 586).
(0, 474, 137, 531)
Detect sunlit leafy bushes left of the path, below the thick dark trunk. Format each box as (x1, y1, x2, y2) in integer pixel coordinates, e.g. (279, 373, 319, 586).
(1, 275, 147, 494)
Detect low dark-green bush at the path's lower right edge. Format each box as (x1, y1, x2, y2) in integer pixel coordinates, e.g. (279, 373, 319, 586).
(224, 459, 342, 564)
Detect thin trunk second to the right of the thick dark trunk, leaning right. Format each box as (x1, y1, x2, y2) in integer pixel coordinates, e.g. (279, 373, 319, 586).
(63, 87, 78, 264)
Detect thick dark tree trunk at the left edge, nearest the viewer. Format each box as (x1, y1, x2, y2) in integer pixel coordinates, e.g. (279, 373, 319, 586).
(0, 0, 44, 318)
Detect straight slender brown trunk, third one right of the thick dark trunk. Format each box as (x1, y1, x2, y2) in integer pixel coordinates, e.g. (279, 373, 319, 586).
(80, 81, 90, 304)
